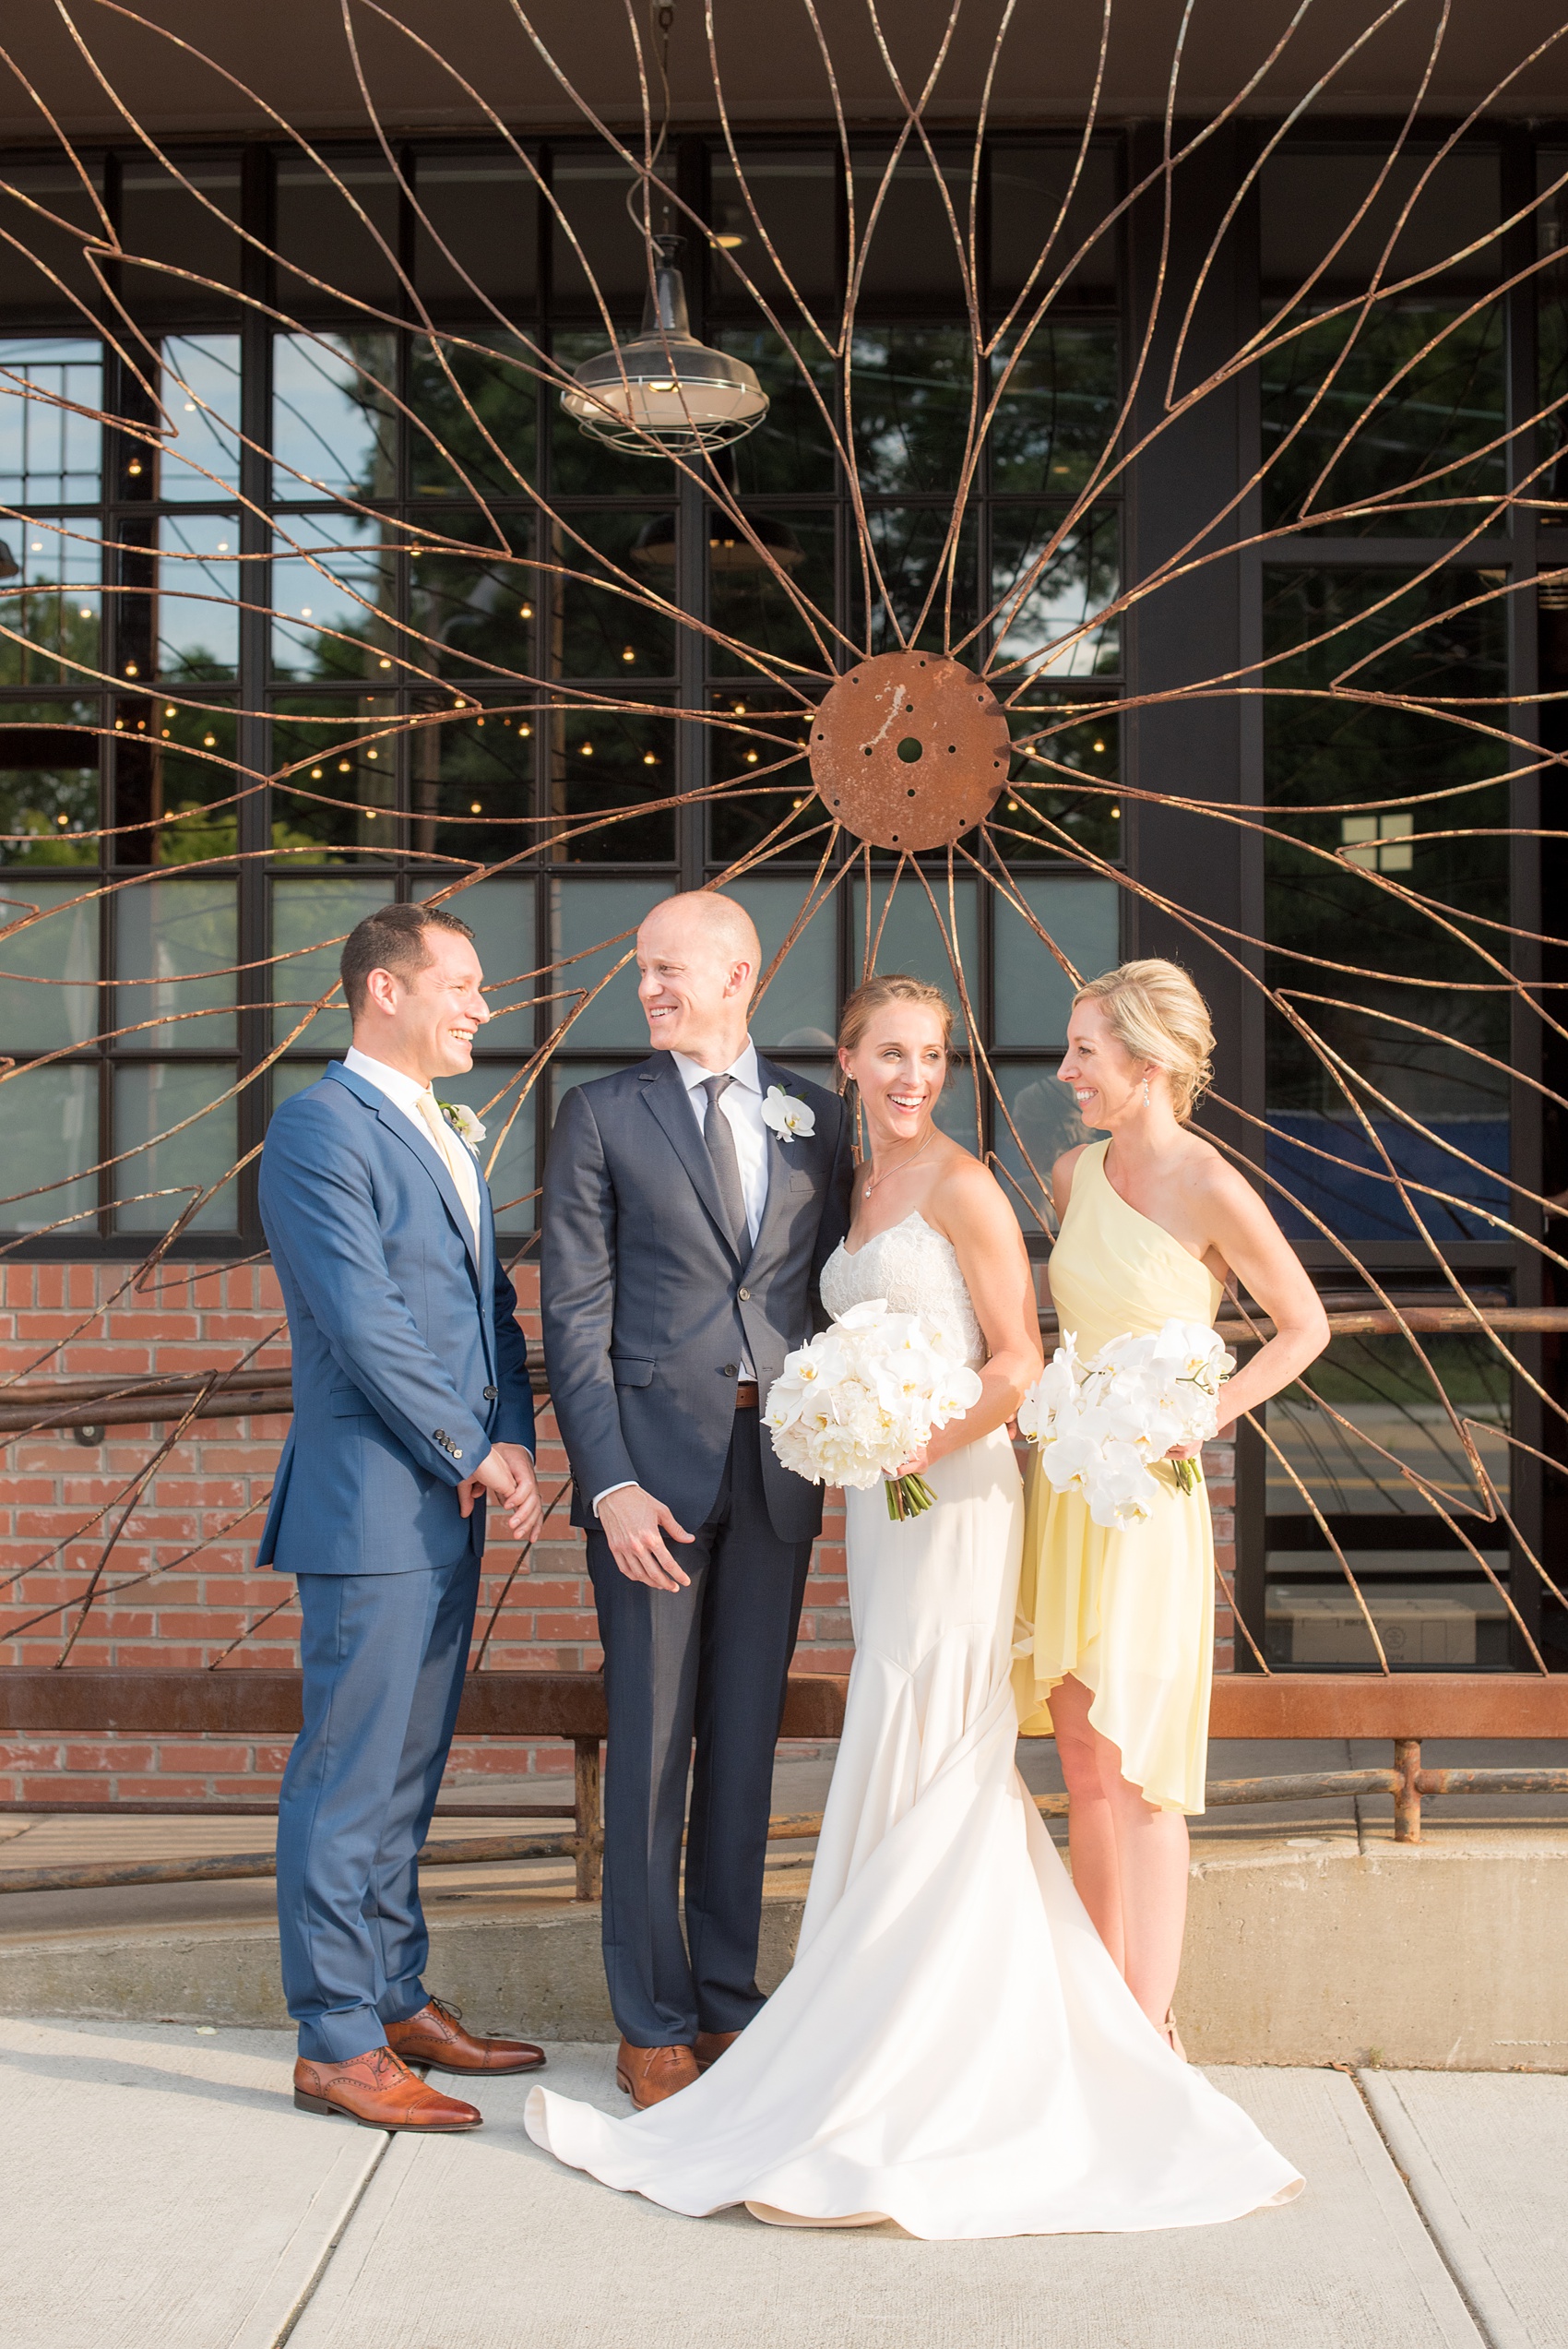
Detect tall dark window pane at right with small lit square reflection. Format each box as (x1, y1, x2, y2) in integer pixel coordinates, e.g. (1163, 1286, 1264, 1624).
(1265, 568, 1509, 1240)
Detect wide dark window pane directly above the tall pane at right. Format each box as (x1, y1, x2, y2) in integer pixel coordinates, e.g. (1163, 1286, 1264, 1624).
(1261, 303, 1507, 538)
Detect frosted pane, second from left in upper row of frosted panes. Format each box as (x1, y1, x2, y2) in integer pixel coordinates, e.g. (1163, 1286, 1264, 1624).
(115, 874, 240, 1053)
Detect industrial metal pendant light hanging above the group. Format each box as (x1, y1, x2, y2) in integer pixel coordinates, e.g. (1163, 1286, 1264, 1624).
(561, 237, 767, 456)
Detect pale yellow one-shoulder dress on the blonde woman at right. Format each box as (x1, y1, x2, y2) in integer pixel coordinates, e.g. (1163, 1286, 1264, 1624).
(1014, 1141, 1223, 1811)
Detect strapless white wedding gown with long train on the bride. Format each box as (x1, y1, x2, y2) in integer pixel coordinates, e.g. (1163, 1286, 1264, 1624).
(526, 1214, 1301, 2238)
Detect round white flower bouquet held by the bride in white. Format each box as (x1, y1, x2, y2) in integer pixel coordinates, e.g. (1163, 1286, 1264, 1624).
(763, 1296, 981, 1518)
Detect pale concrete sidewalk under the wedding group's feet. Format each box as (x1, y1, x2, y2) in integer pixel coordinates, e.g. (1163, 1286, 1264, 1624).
(0, 2021, 1568, 2349)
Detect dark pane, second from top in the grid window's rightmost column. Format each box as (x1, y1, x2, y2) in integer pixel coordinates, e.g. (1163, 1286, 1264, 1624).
(991, 319, 1122, 498)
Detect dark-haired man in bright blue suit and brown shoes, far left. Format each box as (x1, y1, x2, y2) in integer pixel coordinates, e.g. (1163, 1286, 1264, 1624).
(255, 904, 544, 2130)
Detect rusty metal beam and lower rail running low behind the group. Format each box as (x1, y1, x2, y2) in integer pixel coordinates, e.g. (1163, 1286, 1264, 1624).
(0, 1665, 1568, 1901)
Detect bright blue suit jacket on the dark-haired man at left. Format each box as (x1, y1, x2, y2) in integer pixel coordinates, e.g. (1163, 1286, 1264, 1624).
(255, 1062, 533, 1574)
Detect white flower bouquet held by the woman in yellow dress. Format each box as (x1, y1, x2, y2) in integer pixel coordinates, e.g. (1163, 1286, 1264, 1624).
(1018, 1318, 1237, 1532)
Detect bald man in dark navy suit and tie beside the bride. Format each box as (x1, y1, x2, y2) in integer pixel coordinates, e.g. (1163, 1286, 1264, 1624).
(542, 890, 852, 2107)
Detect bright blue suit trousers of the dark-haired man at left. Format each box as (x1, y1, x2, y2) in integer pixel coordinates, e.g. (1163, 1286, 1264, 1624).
(277, 1553, 479, 2062)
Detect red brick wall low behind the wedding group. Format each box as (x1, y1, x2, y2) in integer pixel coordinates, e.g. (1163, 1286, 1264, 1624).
(0, 1261, 1235, 1802)
